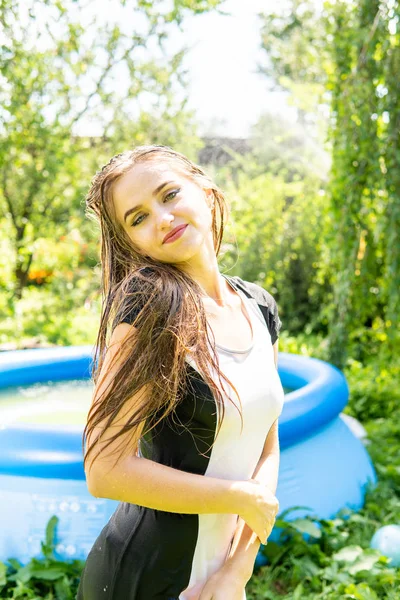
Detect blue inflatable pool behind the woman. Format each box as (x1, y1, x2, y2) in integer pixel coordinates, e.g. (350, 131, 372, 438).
(0, 346, 376, 564)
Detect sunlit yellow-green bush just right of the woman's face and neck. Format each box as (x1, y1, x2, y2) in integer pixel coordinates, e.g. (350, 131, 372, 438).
(209, 151, 331, 334)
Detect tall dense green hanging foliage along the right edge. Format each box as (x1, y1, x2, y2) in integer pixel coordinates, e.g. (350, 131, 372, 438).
(261, 0, 400, 367)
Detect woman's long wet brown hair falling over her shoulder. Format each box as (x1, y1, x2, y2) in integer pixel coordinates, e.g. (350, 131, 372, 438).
(82, 145, 243, 478)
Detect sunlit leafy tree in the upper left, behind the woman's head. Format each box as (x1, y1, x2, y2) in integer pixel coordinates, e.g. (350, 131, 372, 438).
(0, 0, 225, 299)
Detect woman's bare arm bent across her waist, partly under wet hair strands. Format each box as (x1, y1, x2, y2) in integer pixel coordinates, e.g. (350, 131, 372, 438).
(86, 323, 245, 514)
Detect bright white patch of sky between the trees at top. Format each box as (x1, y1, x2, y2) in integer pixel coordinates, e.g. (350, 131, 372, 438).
(172, 0, 296, 137)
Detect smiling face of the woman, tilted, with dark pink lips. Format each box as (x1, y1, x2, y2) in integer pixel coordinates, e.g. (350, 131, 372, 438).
(113, 160, 215, 264)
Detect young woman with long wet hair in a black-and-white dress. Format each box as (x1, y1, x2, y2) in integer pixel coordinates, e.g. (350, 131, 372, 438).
(77, 146, 284, 600)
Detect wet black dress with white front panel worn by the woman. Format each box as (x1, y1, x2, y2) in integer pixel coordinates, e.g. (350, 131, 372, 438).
(77, 275, 284, 600)
